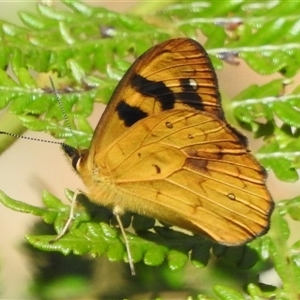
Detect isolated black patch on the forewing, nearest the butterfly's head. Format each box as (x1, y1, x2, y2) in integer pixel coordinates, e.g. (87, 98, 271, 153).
(116, 100, 148, 127)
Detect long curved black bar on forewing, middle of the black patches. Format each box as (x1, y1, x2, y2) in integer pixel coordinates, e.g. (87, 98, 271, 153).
(131, 74, 176, 110)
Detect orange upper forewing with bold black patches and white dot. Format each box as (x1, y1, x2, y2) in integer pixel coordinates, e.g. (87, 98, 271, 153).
(92, 38, 223, 155)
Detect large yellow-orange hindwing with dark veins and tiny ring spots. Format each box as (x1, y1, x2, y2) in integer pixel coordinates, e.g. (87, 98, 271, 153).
(91, 110, 271, 245)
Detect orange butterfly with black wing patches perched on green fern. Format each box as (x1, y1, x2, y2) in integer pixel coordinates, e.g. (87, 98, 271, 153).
(63, 38, 273, 253)
